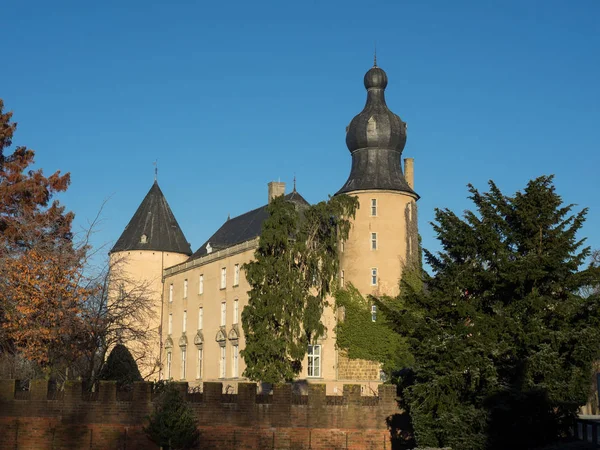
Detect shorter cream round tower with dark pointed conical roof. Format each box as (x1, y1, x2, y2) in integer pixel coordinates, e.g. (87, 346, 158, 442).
(109, 181, 192, 379)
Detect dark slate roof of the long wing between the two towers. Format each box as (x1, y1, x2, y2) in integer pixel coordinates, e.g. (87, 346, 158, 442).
(190, 191, 309, 260)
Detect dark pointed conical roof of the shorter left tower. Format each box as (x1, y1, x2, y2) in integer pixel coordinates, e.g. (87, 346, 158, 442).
(110, 181, 192, 255)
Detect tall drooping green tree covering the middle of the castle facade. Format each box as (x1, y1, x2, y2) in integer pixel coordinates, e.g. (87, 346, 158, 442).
(241, 195, 358, 383)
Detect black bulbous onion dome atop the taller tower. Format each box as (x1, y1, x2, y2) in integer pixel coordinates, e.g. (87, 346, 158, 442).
(338, 66, 418, 198)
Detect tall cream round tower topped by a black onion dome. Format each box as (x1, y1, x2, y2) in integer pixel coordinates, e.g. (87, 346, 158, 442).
(338, 64, 419, 296)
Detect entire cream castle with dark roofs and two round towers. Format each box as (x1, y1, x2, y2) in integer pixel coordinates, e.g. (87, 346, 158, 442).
(111, 64, 419, 393)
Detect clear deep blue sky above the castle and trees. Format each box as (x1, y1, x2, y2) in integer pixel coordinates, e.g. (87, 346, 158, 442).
(0, 0, 600, 268)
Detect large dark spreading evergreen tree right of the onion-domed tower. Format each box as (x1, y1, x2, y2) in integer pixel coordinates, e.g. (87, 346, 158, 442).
(381, 176, 600, 450)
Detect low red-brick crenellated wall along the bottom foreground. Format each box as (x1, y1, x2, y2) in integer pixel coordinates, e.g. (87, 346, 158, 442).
(0, 380, 398, 450)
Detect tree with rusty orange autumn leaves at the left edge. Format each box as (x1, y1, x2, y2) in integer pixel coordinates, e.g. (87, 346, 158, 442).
(0, 99, 86, 372)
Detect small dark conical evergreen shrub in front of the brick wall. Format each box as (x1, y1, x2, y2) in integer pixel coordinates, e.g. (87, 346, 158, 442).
(144, 383, 200, 450)
